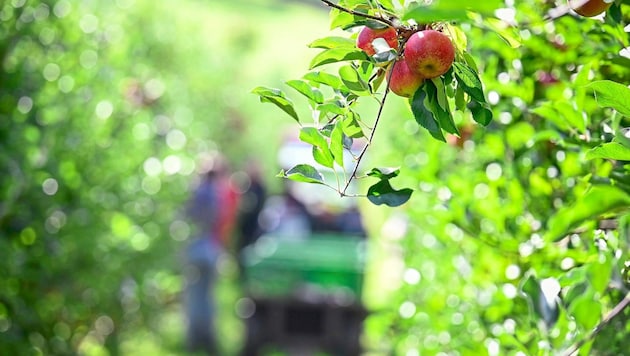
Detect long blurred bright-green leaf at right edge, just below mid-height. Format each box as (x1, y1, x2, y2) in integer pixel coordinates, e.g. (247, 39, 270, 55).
(545, 185, 630, 241)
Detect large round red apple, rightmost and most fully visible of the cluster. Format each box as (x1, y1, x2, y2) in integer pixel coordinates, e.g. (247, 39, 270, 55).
(404, 30, 455, 79)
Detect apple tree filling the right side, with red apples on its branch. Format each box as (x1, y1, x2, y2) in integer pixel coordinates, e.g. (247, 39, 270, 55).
(254, 0, 630, 355)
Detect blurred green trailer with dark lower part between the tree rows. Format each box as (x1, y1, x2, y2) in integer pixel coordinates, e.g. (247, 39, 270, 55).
(242, 233, 366, 355)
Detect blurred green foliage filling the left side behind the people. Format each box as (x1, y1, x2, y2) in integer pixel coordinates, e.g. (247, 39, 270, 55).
(0, 0, 325, 355)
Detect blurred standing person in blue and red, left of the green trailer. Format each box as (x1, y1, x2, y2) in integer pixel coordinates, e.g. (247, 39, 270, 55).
(184, 156, 238, 355)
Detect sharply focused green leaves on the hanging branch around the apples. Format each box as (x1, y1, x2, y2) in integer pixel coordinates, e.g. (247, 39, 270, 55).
(253, 1, 498, 206)
